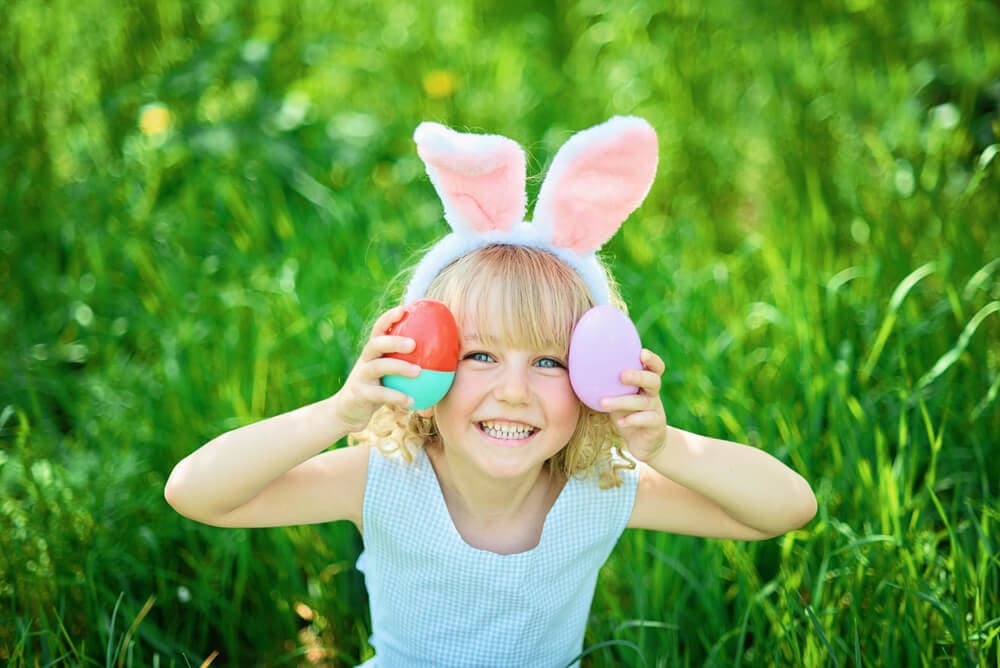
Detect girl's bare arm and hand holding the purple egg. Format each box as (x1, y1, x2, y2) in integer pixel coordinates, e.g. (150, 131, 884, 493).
(604, 350, 816, 540)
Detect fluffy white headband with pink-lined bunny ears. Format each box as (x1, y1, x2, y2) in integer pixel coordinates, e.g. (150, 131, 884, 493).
(404, 116, 657, 305)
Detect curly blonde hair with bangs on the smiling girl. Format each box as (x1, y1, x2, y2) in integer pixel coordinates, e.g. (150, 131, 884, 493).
(349, 244, 635, 487)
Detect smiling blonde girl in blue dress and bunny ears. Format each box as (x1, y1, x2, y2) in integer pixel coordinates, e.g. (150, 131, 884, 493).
(166, 118, 816, 666)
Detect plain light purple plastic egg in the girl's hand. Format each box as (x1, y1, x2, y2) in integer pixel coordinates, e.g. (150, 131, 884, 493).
(569, 306, 642, 412)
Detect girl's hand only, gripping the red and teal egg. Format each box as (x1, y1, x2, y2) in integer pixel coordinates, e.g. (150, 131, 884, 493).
(334, 306, 420, 433)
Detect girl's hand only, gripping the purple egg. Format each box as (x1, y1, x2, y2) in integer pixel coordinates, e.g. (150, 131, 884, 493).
(601, 348, 667, 461)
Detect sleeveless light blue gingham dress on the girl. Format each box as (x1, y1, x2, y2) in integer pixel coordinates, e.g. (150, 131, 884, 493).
(357, 448, 638, 668)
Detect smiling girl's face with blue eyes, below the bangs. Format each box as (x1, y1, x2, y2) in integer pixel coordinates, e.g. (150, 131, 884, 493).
(434, 302, 581, 479)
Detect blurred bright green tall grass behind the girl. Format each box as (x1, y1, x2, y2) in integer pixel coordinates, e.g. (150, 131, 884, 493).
(0, 0, 1000, 666)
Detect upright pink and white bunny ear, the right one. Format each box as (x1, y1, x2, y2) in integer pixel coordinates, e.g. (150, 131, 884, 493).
(533, 116, 658, 255)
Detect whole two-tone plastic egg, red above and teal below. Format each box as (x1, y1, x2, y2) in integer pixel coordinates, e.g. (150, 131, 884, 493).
(382, 299, 461, 410)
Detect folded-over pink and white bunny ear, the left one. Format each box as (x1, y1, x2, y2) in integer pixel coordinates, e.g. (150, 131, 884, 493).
(413, 123, 527, 233)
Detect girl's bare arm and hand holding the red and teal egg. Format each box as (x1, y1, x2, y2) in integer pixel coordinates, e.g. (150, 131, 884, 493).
(164, 309, 419, 528)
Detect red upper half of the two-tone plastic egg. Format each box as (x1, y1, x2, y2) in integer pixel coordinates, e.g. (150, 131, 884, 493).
(386, 299, 461, 371)
